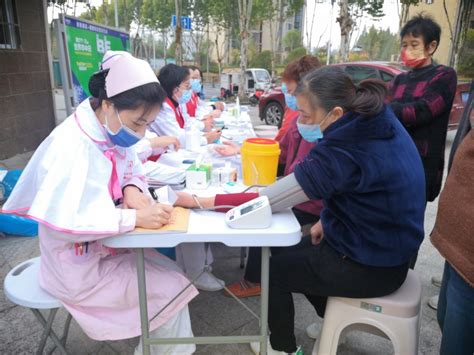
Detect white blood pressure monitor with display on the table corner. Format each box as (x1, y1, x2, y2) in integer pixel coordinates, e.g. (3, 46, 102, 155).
(225, 196, 272, 229)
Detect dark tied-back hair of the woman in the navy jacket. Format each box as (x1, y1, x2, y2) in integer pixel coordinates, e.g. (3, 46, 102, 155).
(295, 66, 387, 116)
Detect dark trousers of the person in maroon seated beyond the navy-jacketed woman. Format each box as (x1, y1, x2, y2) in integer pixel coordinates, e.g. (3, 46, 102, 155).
(244, 208, 319, 283)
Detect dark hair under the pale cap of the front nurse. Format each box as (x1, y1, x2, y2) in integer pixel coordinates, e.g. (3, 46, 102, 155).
(89, 69, 166, 117)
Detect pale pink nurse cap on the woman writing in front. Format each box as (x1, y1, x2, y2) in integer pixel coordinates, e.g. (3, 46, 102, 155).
(101, 51, 159, 97)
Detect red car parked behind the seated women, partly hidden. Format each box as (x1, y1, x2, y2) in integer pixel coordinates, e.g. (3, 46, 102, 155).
(258, 62, 469, 129)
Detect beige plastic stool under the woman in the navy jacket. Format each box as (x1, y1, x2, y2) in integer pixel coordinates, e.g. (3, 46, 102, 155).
(313, 270, 421, 355)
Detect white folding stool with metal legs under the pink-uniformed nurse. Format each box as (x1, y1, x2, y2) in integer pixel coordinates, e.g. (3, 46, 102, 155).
(3, 257, 72, 354)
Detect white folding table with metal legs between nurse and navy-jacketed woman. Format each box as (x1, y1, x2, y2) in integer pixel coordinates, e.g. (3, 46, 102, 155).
(102, 210, 301, 355)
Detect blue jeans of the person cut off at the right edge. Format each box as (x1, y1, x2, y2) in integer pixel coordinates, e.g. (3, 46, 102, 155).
(438, 262, 474, 355)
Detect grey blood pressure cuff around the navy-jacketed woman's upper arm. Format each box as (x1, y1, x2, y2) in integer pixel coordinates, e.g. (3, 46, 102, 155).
(260, 174, 309, 212)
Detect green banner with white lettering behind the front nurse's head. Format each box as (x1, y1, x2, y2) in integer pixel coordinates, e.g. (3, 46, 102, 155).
(64, 16, 130, 106)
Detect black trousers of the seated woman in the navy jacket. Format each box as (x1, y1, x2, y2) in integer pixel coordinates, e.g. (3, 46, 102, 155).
(268, 238, 408, 353)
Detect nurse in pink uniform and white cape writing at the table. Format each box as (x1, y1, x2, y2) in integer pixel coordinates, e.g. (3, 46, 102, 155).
(2, 51, 198, 354)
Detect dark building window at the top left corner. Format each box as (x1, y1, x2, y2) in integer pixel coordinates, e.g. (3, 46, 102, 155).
(0, 0, 20, 49)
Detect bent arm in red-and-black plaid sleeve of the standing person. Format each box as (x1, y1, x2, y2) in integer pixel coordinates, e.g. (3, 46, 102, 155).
(390, 68, 457, 127)
